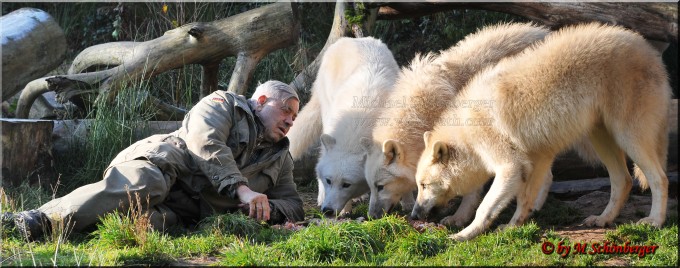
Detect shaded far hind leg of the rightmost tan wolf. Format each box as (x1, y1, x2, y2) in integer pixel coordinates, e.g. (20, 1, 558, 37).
(584, 127, 633, 227)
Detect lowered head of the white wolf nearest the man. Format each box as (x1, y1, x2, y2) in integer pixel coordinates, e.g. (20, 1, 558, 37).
(316, 134, 369, 215)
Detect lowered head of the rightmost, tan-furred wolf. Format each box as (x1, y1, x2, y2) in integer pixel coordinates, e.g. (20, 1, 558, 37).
(411, 131, 488, 219)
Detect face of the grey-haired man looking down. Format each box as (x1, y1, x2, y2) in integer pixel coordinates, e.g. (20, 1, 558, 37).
(255, 96, 300, 142)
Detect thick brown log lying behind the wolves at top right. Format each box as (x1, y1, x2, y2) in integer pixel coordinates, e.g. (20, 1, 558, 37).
(373, 2, 678, 43)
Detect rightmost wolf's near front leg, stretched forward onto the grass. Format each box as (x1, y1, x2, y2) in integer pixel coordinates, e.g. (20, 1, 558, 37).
(449, 165, 522, 241)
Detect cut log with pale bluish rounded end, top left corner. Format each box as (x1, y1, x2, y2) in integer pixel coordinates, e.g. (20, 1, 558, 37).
(0, 8, 66, 101)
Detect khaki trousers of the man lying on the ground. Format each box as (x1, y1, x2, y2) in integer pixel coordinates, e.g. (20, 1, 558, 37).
(38, 160, 194, 231)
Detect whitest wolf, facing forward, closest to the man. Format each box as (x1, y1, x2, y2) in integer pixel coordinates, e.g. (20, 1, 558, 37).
(288, 37, 399, 214)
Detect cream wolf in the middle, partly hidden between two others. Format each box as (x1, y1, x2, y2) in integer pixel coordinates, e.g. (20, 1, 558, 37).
(362, 23, 549, 220)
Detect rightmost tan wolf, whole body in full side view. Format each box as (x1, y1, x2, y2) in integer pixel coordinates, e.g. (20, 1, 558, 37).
(412, 23, 671, 240)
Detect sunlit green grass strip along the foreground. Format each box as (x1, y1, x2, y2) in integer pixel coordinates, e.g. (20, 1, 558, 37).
(0, 188, 678, 266)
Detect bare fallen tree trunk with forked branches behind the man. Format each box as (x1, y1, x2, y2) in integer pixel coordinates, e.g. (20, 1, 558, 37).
(17, 3, 299, 118)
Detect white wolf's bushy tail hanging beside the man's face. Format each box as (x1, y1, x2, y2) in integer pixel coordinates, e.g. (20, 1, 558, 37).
(288, 94, 323, 160)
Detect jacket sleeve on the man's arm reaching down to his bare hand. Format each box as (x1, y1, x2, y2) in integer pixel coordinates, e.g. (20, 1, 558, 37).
(182, 93, 248, 198)
